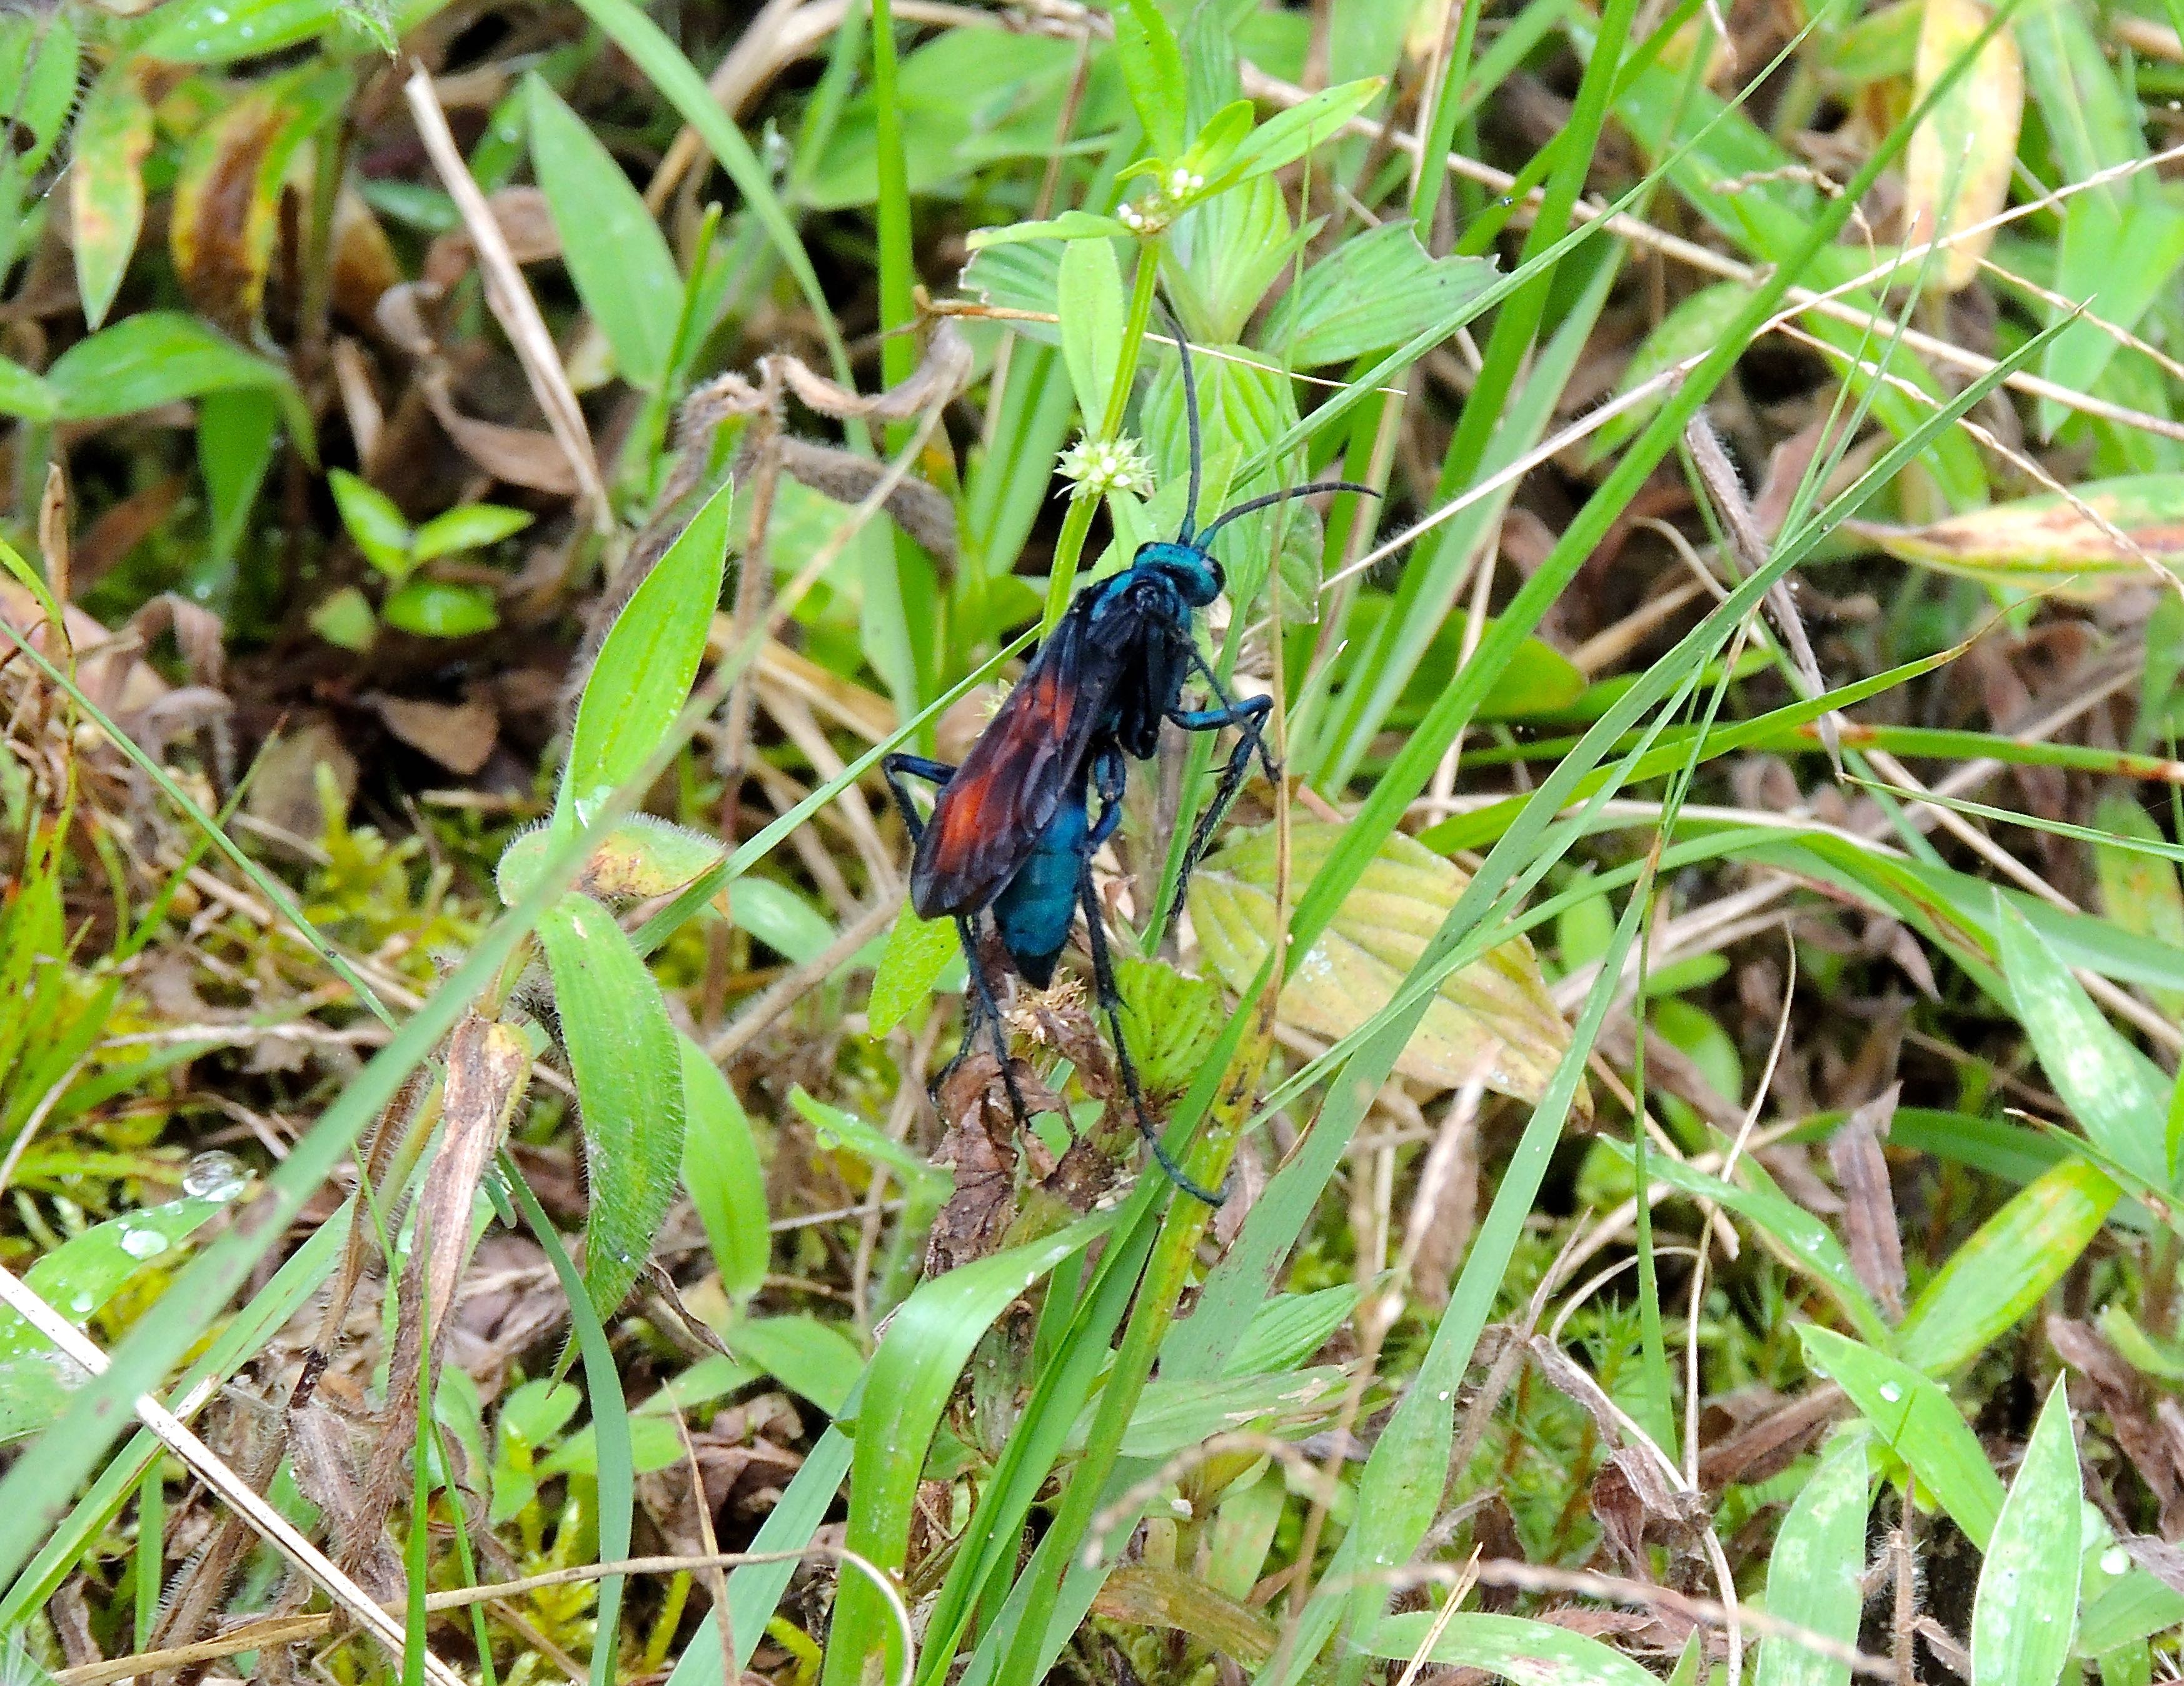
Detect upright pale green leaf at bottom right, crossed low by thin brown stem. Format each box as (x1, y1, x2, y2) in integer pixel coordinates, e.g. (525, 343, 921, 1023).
(1751, 1433, 1865, 1686)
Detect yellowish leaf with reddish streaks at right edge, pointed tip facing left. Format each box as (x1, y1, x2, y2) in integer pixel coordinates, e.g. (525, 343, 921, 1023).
(1846, 474, 2184, 603)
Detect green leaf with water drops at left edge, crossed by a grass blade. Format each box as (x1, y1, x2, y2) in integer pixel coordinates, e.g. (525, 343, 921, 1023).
(0, 1182, 243, 1443)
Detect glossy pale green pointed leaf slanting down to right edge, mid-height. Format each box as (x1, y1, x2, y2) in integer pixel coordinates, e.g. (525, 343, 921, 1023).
(1994, 904, 2169, 1188)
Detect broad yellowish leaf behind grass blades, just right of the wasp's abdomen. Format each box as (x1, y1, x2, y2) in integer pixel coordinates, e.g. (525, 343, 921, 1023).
(1190, 821, 1570, 1101)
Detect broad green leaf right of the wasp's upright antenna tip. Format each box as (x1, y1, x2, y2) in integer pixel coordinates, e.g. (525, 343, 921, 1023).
(1260, 221, 1494, 369)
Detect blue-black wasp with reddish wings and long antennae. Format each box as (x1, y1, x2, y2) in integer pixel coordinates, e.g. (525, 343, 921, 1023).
(885, 314, 1378, 1205)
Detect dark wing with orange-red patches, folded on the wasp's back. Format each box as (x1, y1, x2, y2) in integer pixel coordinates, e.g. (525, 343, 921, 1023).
(911, 592, 1142, 920)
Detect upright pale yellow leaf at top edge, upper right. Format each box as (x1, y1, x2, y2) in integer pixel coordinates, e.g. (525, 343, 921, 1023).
(1905, 0, 2025, 293)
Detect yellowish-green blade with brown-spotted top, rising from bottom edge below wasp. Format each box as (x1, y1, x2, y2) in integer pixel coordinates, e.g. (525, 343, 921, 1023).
(998, 1000, 1273, 1680)
